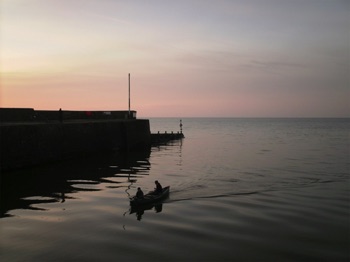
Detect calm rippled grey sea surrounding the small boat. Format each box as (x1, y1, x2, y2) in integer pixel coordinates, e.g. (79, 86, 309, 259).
(0, 118, 350, 261)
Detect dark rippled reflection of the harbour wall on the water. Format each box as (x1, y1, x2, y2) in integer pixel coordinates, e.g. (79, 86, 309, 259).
(0, 151, 150, 217)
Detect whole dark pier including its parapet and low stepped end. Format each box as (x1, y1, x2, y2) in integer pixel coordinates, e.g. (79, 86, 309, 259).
(0, 108, 184, 170)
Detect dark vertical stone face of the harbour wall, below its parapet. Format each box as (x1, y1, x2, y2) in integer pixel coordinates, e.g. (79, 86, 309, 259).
(0, 119, 151, 170)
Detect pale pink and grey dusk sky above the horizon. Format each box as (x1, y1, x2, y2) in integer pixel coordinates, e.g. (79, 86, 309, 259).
(0, 0, 350, 117)
